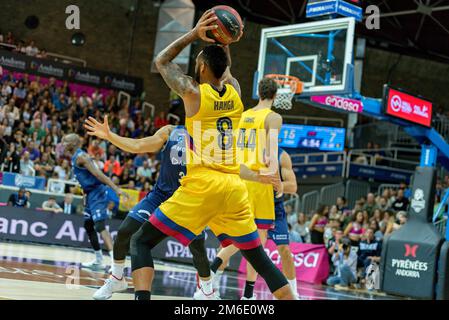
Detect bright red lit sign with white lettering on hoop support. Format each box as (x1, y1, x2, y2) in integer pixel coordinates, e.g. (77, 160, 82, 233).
(384, 86, 432, 127)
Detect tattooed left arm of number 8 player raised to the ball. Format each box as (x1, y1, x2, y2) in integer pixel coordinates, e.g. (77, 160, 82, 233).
(155, 10, 217, 99)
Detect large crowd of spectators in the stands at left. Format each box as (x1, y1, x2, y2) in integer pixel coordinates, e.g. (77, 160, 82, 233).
(0, 65, 172, 212)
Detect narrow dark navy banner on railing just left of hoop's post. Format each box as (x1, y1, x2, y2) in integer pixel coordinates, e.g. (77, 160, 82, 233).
(349, 163, 413, 183)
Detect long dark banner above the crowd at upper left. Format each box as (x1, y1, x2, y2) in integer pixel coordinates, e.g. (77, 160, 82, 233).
(0, 50, 143, 95)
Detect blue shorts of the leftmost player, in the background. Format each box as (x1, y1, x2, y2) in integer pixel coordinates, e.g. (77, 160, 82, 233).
(84, 185, 113, 222)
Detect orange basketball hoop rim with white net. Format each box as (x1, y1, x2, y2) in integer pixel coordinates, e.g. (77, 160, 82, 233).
(265, 74, 304, 110)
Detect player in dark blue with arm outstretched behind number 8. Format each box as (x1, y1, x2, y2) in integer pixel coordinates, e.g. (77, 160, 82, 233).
(85, 116, 215, 300)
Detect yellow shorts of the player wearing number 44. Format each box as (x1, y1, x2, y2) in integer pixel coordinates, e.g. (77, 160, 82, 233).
(245, 181, 275, 230)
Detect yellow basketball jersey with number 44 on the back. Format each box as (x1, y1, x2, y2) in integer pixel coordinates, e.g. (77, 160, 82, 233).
(237, 109, 273, 171)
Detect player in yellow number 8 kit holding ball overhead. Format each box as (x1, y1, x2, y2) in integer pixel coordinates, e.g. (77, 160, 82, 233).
(131, 10, 294, 300)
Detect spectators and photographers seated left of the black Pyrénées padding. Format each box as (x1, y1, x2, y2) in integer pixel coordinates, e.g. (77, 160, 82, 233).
(286, 184, 416, 289)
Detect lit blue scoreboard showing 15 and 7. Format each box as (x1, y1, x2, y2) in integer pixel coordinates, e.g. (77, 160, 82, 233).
(279, 124, 346, 152)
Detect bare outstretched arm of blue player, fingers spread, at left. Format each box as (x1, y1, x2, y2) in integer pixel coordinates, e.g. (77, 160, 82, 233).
(84, 116, 174, 153)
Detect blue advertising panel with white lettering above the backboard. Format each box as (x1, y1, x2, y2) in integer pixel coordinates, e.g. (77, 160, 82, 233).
(306, 0, 363, 21)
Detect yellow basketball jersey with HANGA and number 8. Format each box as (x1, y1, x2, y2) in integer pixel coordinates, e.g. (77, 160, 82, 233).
(186, 84, 243, 174)
